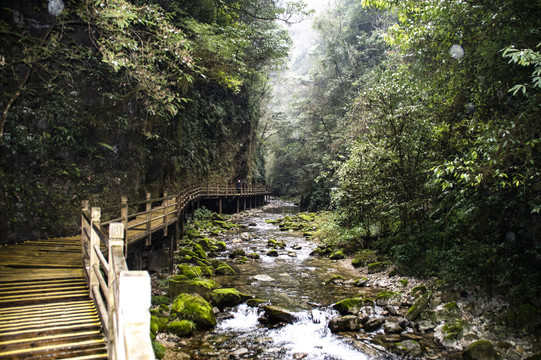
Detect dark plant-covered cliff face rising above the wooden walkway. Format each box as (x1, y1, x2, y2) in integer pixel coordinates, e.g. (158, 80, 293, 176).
(0, 0, 257, 243)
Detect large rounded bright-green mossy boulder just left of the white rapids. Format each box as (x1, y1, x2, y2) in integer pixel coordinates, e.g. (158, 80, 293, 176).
(171, 294, 216, 329)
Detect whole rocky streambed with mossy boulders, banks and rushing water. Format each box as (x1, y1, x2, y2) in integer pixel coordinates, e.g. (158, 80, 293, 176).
(153, 202, 541, 359)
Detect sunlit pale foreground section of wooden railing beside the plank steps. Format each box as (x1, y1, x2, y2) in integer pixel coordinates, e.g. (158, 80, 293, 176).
(81, 202, 154, 359)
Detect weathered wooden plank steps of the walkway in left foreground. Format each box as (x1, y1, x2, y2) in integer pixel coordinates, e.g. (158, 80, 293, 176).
(0, 238, 107, 359)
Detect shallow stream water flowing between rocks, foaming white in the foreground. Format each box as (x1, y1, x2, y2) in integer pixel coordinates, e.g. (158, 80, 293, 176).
(182, 201, 394, 360)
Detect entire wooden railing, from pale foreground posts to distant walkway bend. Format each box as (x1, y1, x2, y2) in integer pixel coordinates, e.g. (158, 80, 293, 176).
(81, 184, 270, 359)
